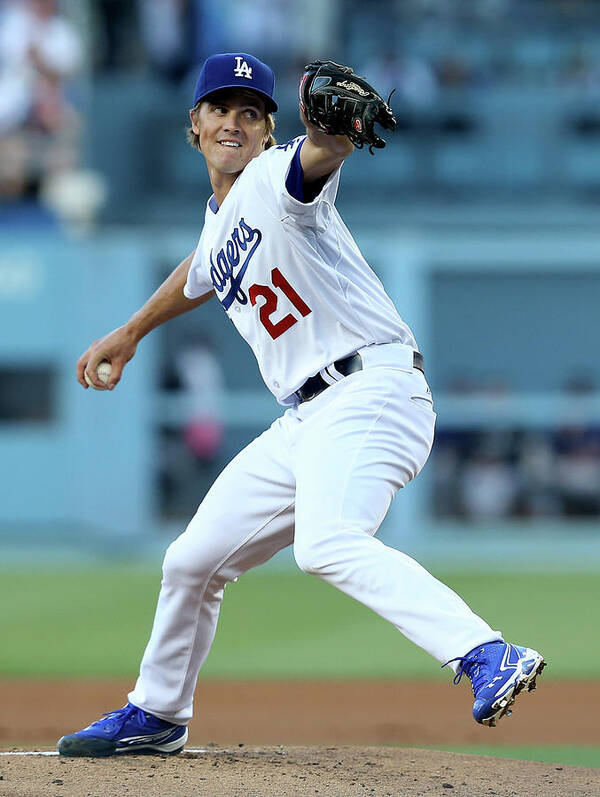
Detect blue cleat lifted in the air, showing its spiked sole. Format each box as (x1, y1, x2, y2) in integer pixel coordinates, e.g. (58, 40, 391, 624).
(444, 642, 546, 727)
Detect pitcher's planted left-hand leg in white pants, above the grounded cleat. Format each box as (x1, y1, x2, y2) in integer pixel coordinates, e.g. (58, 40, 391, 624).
(129, 420, 294, 724)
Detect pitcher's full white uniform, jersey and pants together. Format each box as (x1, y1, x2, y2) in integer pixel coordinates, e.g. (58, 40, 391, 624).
(129, 132, 502, 725)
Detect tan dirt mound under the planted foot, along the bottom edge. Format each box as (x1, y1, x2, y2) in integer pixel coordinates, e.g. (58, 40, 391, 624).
(0, 745, 600, 797)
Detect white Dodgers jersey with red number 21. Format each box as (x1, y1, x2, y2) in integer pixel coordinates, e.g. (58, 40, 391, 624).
(184, 136, 417, 404)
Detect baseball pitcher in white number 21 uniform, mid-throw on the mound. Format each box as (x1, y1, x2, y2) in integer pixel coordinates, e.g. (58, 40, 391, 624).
(58, 53, 544, 756)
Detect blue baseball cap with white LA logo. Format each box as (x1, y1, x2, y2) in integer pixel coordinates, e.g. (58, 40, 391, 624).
(194, 53, 277, 113)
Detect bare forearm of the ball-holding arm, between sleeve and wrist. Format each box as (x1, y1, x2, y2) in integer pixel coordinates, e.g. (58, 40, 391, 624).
(125, 253, 214, 342)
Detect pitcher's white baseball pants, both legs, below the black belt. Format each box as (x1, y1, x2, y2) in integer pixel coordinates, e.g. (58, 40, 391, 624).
(129, 343, 502, 724)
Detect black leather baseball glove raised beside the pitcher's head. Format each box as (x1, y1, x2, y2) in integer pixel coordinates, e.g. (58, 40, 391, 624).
(300, 61, 396, 155)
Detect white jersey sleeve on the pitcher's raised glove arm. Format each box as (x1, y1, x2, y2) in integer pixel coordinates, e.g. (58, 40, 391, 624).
(256, 136, 342, 228)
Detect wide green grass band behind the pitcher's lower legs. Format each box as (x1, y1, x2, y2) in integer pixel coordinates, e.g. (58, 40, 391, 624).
(0, 566, 600, 679)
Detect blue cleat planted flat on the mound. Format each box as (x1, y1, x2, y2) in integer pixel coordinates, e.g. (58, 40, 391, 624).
(58, 703, 188, 756)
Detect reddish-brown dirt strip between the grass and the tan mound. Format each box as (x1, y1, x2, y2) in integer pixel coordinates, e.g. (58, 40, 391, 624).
(0, 680, 600, 748)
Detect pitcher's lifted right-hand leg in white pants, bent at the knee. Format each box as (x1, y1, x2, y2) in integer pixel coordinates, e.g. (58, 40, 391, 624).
(294, 368, 502, 662)
